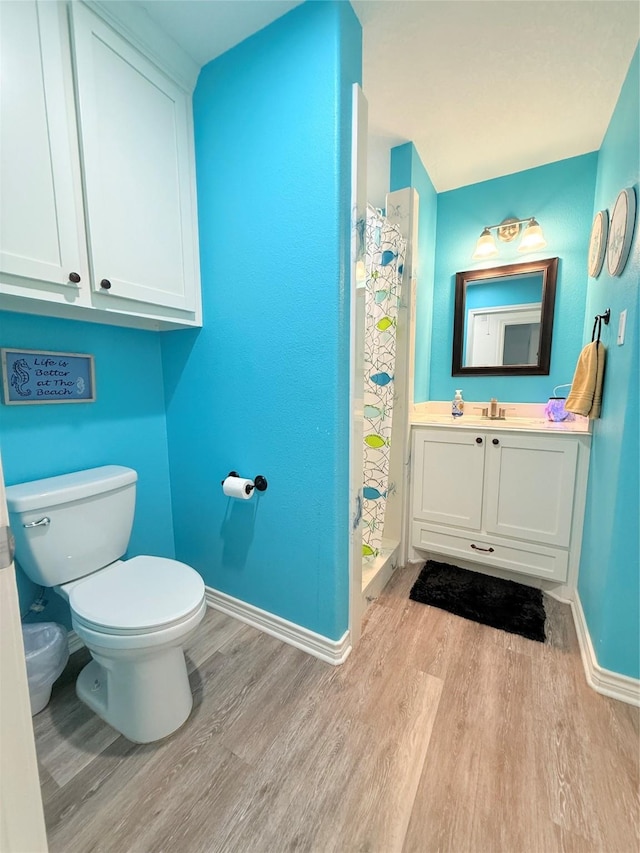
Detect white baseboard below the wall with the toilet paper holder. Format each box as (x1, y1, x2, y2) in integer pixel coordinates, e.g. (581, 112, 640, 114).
(205, 586, 351, 666)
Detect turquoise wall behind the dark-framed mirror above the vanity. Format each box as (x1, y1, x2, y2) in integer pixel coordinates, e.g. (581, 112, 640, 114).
(428, 153, 597, 402)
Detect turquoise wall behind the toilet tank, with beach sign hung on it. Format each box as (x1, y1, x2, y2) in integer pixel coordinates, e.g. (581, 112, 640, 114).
(0, 312, 174, 627)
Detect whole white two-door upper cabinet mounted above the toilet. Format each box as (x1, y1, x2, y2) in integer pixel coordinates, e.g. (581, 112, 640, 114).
(0, 0, 201, 329)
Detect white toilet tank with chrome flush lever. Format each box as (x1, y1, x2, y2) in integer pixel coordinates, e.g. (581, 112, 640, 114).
(6, 465, 138, 586)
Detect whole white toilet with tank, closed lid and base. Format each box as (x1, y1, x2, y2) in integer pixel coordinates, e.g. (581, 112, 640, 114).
(7, 465, 206, 743)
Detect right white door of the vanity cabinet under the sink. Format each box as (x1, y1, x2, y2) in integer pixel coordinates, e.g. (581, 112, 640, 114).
(483, 433, 578, 547)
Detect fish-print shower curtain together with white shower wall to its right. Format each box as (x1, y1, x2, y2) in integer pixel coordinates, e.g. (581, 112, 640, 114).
(362, 189, 418, 608)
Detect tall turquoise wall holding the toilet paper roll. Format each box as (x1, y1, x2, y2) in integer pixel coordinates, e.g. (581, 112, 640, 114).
(162, 2, 362, 639)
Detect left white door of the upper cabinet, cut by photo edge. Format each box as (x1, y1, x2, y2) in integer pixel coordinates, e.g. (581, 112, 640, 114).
(0, 0, 84, 290)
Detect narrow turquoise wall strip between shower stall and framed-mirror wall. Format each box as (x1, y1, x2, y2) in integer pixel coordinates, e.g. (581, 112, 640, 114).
(390, 142, 438, 403)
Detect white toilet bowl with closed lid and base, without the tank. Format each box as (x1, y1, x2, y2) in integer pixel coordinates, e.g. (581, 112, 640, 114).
(56, 556, 206, 743)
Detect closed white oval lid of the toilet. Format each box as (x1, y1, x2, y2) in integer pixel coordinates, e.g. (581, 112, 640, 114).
(69, 557, 204, 633)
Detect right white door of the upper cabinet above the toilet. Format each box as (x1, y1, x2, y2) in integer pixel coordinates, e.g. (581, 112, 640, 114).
(71, 3, 196, 311)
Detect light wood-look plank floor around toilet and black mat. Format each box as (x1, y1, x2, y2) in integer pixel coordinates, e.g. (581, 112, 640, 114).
(34, 568, 640, 853)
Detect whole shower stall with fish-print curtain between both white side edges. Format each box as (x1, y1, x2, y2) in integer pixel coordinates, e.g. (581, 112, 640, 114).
(349, 86, 418, 646)
